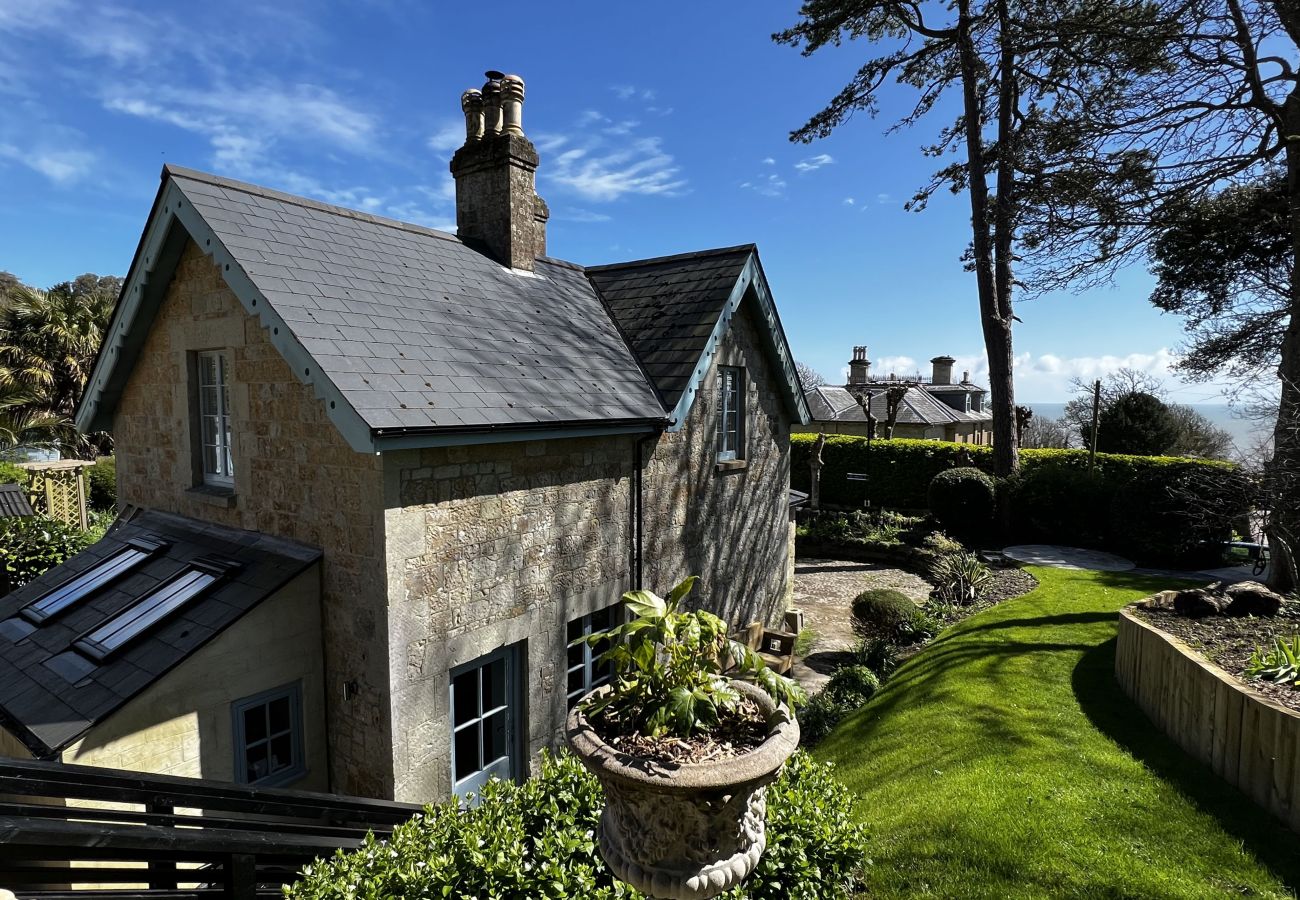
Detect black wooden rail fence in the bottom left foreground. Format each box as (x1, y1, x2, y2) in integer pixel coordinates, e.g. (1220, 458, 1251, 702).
(0, 760, 420, 900)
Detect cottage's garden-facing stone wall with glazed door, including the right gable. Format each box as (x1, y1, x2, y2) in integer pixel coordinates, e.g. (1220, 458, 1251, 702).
(385, 295, 790, 801)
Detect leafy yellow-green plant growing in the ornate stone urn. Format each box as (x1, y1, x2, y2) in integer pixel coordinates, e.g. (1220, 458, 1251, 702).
(575, 575, 801, 737)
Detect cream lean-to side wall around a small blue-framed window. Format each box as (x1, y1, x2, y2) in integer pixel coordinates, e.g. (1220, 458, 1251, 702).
(62, 568, 329, 791)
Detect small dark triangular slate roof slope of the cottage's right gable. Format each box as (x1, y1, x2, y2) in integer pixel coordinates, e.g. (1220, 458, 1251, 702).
(586, 249, 755, 410)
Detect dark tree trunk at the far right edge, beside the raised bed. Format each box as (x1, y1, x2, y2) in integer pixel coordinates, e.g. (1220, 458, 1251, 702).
(1269, 91, 1300, 593)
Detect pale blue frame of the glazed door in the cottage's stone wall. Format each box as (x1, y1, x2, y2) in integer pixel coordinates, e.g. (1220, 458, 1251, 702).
(447, 642, 527, 802)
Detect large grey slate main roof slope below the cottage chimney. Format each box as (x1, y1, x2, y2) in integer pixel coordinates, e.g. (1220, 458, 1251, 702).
(159, 166, 666, 429)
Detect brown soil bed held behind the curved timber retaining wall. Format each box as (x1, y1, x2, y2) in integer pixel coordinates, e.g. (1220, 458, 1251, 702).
(1134, 605, 1300, 711)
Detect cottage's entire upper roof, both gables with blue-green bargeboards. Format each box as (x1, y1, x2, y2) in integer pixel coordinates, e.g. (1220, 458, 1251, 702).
(77, 165, 802, 450)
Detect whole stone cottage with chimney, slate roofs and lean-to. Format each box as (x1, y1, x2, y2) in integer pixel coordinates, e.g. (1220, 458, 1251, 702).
(0, 73, 809, 801)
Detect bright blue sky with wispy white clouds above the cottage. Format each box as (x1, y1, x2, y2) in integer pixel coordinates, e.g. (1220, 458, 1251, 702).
(0, 0, 1237, 402)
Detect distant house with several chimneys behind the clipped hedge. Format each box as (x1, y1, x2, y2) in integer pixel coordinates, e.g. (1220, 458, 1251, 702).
(794, 347, 993, 443)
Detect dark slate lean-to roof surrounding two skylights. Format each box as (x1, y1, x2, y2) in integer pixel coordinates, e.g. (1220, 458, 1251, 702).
(0, 511, 321, 758)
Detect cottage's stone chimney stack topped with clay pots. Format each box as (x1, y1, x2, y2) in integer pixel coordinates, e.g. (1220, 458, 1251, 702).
(451, 72, 550, 272)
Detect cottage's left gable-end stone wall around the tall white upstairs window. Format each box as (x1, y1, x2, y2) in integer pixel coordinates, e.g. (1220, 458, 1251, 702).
(113, 243, 391, 797)
